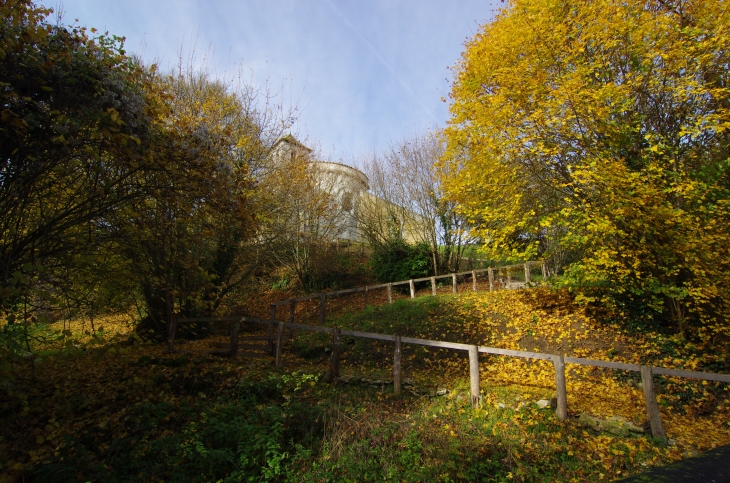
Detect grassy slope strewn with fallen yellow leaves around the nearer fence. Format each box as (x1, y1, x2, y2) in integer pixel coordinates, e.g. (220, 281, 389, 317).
(0, 291, 730, 481)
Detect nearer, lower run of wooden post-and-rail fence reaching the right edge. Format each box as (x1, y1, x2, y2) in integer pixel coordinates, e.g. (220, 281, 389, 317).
(168, 314, 730, 441)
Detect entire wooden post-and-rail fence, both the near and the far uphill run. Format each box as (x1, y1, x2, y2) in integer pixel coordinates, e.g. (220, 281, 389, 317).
(168, 262, 730, 441)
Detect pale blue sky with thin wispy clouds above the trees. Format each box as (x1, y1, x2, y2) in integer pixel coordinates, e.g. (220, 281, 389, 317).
(40, 0, 502, 163)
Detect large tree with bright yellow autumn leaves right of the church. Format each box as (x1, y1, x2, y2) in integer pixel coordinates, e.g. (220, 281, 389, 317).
(439, 0, 730, 336)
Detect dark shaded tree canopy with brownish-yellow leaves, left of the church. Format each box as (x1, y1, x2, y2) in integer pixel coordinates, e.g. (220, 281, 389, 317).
(0, 0, 291, 334)
